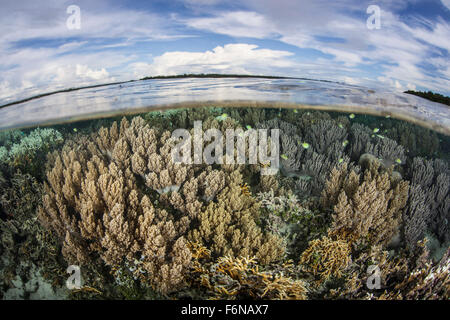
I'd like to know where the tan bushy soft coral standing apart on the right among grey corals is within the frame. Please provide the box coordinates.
[321,163,409,245]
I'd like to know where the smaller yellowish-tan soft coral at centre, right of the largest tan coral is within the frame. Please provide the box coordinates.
[190,171,285,264]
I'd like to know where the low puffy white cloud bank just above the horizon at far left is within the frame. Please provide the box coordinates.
[0,48,135,101]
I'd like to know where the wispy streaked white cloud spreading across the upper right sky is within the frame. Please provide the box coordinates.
[184,0,450,92]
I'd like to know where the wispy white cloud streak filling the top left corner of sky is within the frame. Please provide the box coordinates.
[0,1,186,44]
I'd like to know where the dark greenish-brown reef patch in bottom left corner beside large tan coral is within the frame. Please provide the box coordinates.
[0,172,68,299]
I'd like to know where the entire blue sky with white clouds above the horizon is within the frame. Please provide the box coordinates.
[0,0,450,104]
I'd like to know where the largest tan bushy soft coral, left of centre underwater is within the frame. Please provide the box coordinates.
[39,120,195,292]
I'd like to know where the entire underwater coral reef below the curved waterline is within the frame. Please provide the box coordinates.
[0,107,450,298]
